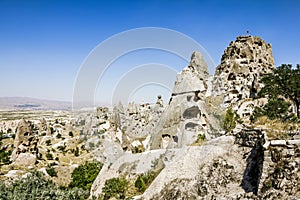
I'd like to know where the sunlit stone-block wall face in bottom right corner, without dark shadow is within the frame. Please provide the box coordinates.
[259,140,300,199]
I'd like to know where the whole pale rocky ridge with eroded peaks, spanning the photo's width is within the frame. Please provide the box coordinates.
[0,36,300,199]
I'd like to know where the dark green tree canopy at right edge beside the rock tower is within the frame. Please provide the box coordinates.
[259,64,300,118]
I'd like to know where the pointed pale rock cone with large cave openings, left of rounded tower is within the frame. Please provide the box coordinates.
[150,52,216,149]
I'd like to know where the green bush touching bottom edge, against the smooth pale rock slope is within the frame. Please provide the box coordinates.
[102,177,128,199]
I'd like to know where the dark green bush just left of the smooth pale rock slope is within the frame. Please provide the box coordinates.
[69,161,103,190]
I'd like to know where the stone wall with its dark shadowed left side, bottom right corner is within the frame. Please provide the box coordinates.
[235,129,300,199]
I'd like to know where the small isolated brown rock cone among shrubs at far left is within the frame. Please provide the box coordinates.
[11,120,38,166]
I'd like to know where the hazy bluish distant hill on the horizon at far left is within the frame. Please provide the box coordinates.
[0,97,72,110]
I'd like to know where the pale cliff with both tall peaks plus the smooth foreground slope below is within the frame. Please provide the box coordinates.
[91,36,299,199]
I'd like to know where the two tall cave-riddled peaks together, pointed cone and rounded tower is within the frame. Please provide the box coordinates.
[151,36,274,149]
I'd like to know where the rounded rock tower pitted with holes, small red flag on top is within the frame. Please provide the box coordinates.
[213,36,274,107]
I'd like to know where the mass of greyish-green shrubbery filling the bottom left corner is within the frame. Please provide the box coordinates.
[0,171,89,200]
